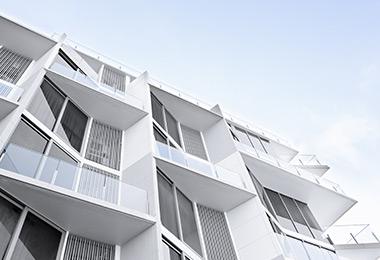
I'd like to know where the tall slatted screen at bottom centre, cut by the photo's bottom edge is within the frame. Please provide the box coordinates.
[198,205,237,260]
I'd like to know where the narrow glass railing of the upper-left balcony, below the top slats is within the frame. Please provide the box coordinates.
[50,62,144,110]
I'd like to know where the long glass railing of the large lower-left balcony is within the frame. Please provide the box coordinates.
[0,144,149,213]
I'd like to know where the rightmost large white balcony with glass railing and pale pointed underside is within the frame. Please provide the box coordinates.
[235,142,356,229]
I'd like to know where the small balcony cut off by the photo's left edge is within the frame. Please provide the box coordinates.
[0,79,24,120]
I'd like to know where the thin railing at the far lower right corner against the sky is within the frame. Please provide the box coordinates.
[328,224,380,245]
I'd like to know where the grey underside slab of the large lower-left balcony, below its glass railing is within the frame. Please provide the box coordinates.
[0,169,154,244]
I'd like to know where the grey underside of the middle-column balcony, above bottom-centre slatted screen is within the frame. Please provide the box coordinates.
[156,157,255,211]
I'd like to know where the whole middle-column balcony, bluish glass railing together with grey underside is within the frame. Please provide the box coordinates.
[155,142,255,211]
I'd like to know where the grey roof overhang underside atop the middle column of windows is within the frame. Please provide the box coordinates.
[151,87,222,131]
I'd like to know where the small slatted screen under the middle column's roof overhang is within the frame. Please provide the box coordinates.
[181,125,207,160]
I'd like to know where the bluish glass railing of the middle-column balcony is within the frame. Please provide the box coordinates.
[156,141,246,188]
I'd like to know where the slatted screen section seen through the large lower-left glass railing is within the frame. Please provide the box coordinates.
[78,165,119,203]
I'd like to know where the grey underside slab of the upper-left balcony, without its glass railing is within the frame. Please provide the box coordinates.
[46,70,148,130]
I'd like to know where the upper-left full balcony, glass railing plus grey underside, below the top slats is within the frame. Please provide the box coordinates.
[46,62,148,130]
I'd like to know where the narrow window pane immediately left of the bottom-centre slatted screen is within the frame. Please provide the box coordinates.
[177,189,202,255]
